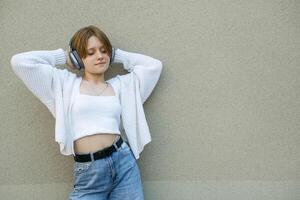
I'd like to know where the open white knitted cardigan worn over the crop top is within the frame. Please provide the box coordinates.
[10,49,163,159]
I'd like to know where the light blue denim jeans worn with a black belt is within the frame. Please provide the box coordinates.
[69,142,144,200]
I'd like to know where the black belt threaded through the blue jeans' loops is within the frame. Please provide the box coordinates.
[73,136,123,162]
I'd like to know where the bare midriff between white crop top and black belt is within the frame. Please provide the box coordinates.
[74,133,120,154]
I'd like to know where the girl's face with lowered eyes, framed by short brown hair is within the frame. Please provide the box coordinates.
[82,36,110,74]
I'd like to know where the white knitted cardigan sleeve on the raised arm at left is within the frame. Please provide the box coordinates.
[10,49,71,109]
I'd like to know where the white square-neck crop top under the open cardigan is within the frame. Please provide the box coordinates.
[71,82,121,141]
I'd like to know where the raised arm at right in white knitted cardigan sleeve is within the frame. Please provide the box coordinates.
[114,49,163,103]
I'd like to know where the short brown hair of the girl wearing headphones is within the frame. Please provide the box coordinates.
[70,25,112,58]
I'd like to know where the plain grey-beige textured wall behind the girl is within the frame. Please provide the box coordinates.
[0,0,300,200]
